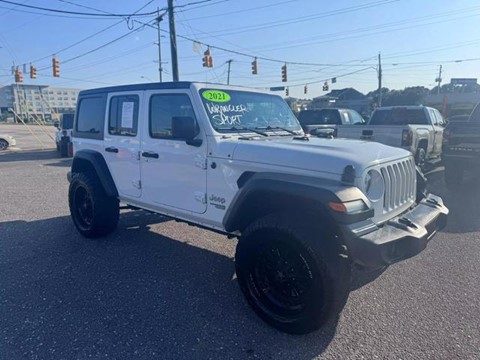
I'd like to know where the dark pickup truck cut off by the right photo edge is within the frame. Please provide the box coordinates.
[442,104,480,189]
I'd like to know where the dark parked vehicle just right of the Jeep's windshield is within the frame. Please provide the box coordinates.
[298,108,365,136]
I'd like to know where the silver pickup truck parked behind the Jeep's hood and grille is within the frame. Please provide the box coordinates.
[337,106,445,170]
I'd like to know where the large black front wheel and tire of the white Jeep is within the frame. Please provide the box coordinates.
[235,214,350,334]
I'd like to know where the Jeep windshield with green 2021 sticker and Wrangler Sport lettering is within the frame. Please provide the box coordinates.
[200,89,301,132]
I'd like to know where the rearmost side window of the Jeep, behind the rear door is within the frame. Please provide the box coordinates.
[75,96,106,139]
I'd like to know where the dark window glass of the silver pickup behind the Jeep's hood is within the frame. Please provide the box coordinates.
[369,108,428,125]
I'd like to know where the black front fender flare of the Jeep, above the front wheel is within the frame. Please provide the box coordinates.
[223,172,373,232]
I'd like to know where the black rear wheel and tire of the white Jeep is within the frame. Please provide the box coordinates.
[68,173,120,238]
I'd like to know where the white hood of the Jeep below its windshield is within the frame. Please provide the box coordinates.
[232,137,411,175]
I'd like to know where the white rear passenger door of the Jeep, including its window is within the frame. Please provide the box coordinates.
[103,91,143,198]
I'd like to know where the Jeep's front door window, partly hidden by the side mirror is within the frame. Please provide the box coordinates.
[149,94,196,139]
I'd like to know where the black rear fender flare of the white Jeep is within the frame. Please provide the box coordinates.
[72,149,118,197]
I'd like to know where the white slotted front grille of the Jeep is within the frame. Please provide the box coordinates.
[380,158,416,213]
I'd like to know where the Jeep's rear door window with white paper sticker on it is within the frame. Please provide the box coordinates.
[108,95,139,136]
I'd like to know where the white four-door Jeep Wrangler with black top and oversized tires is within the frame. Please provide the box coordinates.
[69,82,448,334]
